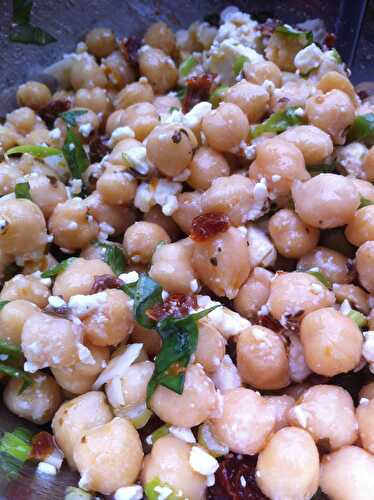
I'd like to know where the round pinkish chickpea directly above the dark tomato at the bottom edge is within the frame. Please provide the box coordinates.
[210,388,275,455]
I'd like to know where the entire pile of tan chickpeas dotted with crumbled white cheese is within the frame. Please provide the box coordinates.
[0,7,374,500]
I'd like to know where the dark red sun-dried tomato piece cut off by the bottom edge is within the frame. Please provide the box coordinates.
[206,453,268,500]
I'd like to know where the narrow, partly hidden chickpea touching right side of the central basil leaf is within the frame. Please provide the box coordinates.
[195,321,226,373]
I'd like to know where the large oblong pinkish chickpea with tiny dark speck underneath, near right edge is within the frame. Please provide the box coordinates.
[292,174,360,229]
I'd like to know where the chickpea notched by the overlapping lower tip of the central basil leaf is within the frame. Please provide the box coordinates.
[150,365,217,427]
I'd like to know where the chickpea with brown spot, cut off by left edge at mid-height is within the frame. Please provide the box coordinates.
[0,198,47,256]
